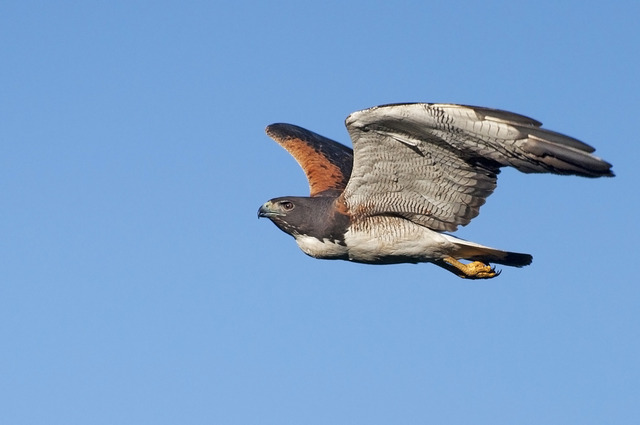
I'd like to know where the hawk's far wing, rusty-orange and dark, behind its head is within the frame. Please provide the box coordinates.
[266,124,353,196]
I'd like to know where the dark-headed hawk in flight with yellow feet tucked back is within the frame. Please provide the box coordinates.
[258,103,614,279]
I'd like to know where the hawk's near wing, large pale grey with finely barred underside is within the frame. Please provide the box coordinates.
[344,103,613,231]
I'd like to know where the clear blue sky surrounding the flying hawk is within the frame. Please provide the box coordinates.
[0,0,640,425]
